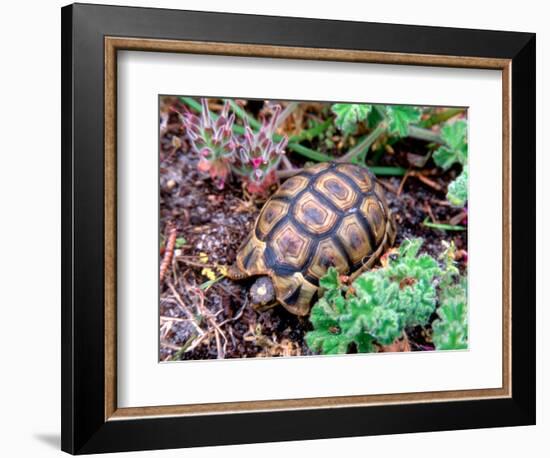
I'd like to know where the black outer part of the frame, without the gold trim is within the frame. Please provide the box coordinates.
[61,4,536,454]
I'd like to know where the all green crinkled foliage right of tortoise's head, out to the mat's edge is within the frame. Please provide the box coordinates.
[305,239,468,354]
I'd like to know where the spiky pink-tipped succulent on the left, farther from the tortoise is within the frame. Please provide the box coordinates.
[183,98,237,189]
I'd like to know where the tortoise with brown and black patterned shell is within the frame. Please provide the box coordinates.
[228,163,396,316]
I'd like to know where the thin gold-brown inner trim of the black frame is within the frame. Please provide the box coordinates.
[104,37,512,421]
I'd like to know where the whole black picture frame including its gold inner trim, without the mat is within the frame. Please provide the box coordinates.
[61,4,536,454]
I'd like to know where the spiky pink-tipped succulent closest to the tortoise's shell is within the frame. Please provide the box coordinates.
[231,106,288,194]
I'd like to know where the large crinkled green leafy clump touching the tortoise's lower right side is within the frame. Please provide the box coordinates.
[305,239,442,354]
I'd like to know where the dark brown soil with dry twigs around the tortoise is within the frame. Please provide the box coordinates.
[160,99,467,361]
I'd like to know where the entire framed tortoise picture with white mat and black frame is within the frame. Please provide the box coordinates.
[62,4,536,454]
